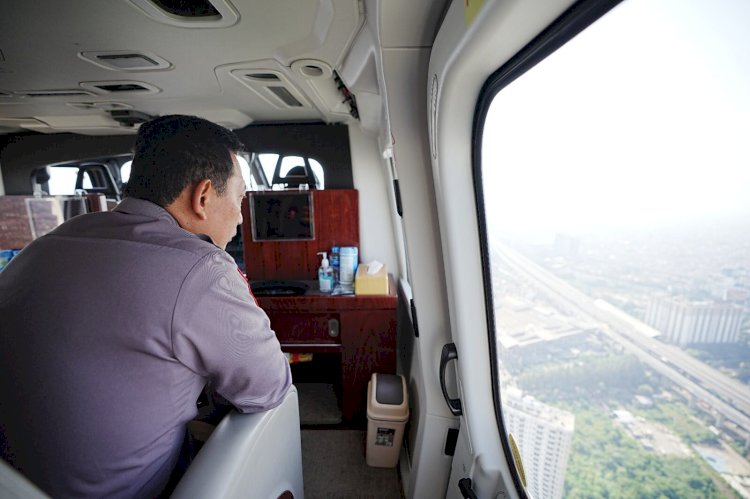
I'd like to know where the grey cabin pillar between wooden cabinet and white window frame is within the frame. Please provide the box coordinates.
[382,42,458,497]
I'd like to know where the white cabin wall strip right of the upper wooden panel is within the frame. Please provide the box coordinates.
[349,126,401,279]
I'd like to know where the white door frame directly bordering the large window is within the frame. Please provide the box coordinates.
[429,0,571,497]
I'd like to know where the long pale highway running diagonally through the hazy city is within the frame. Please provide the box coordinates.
[492,241,750,433]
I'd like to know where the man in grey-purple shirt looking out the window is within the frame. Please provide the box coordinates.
[0,116,291,497]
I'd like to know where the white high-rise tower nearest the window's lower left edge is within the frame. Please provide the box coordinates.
[503,388,575,499]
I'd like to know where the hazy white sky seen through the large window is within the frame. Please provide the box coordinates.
[483,0,750,236]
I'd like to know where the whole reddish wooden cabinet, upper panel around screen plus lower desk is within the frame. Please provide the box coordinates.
[242,189,397,421]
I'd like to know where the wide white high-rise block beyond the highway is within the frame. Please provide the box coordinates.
[645,298,744,346]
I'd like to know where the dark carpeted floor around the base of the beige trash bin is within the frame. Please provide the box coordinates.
[302,429,403,499]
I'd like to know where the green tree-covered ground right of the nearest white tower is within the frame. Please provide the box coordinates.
[564,404,727,499]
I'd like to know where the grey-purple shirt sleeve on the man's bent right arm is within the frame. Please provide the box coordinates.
[172,251,292,413]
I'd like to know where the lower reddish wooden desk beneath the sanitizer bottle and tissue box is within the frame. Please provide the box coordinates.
[258,286,397,421]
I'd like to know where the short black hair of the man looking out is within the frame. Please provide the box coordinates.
[124,114,244,207]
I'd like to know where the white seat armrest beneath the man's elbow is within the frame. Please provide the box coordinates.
[172,386,304,499]
